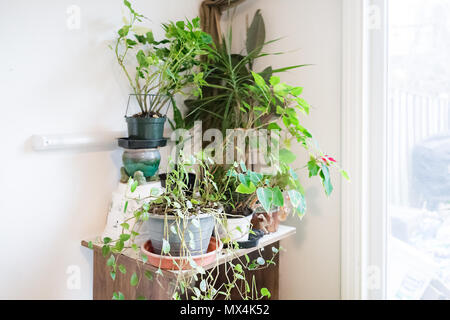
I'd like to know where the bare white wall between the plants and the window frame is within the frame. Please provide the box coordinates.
[224,0,342,299]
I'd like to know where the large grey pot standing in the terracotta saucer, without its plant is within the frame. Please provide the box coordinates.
[145,214,215,256]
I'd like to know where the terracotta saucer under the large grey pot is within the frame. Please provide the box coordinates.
[141,237,223,270]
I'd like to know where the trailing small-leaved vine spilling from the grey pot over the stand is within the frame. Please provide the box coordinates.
[89,153,279,300]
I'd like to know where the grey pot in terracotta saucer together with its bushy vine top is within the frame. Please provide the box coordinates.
[142,153,223,256]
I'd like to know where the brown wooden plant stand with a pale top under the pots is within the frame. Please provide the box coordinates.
[81,225,296,300]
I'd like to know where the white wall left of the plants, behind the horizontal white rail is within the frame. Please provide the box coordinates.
[0,0,200,299]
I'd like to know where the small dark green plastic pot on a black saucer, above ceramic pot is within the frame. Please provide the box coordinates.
[125,116,166,140]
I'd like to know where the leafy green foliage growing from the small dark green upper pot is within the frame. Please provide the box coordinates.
[114,0,212,117]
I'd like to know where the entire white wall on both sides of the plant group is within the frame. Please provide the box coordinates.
[0,0,341,299]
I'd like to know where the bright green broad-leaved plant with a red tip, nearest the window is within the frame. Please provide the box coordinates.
[229,72,348,216]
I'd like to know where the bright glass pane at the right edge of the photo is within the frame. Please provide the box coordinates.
[387,0,450,299]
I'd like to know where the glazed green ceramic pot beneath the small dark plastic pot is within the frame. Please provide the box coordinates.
[122,149,161,178]
